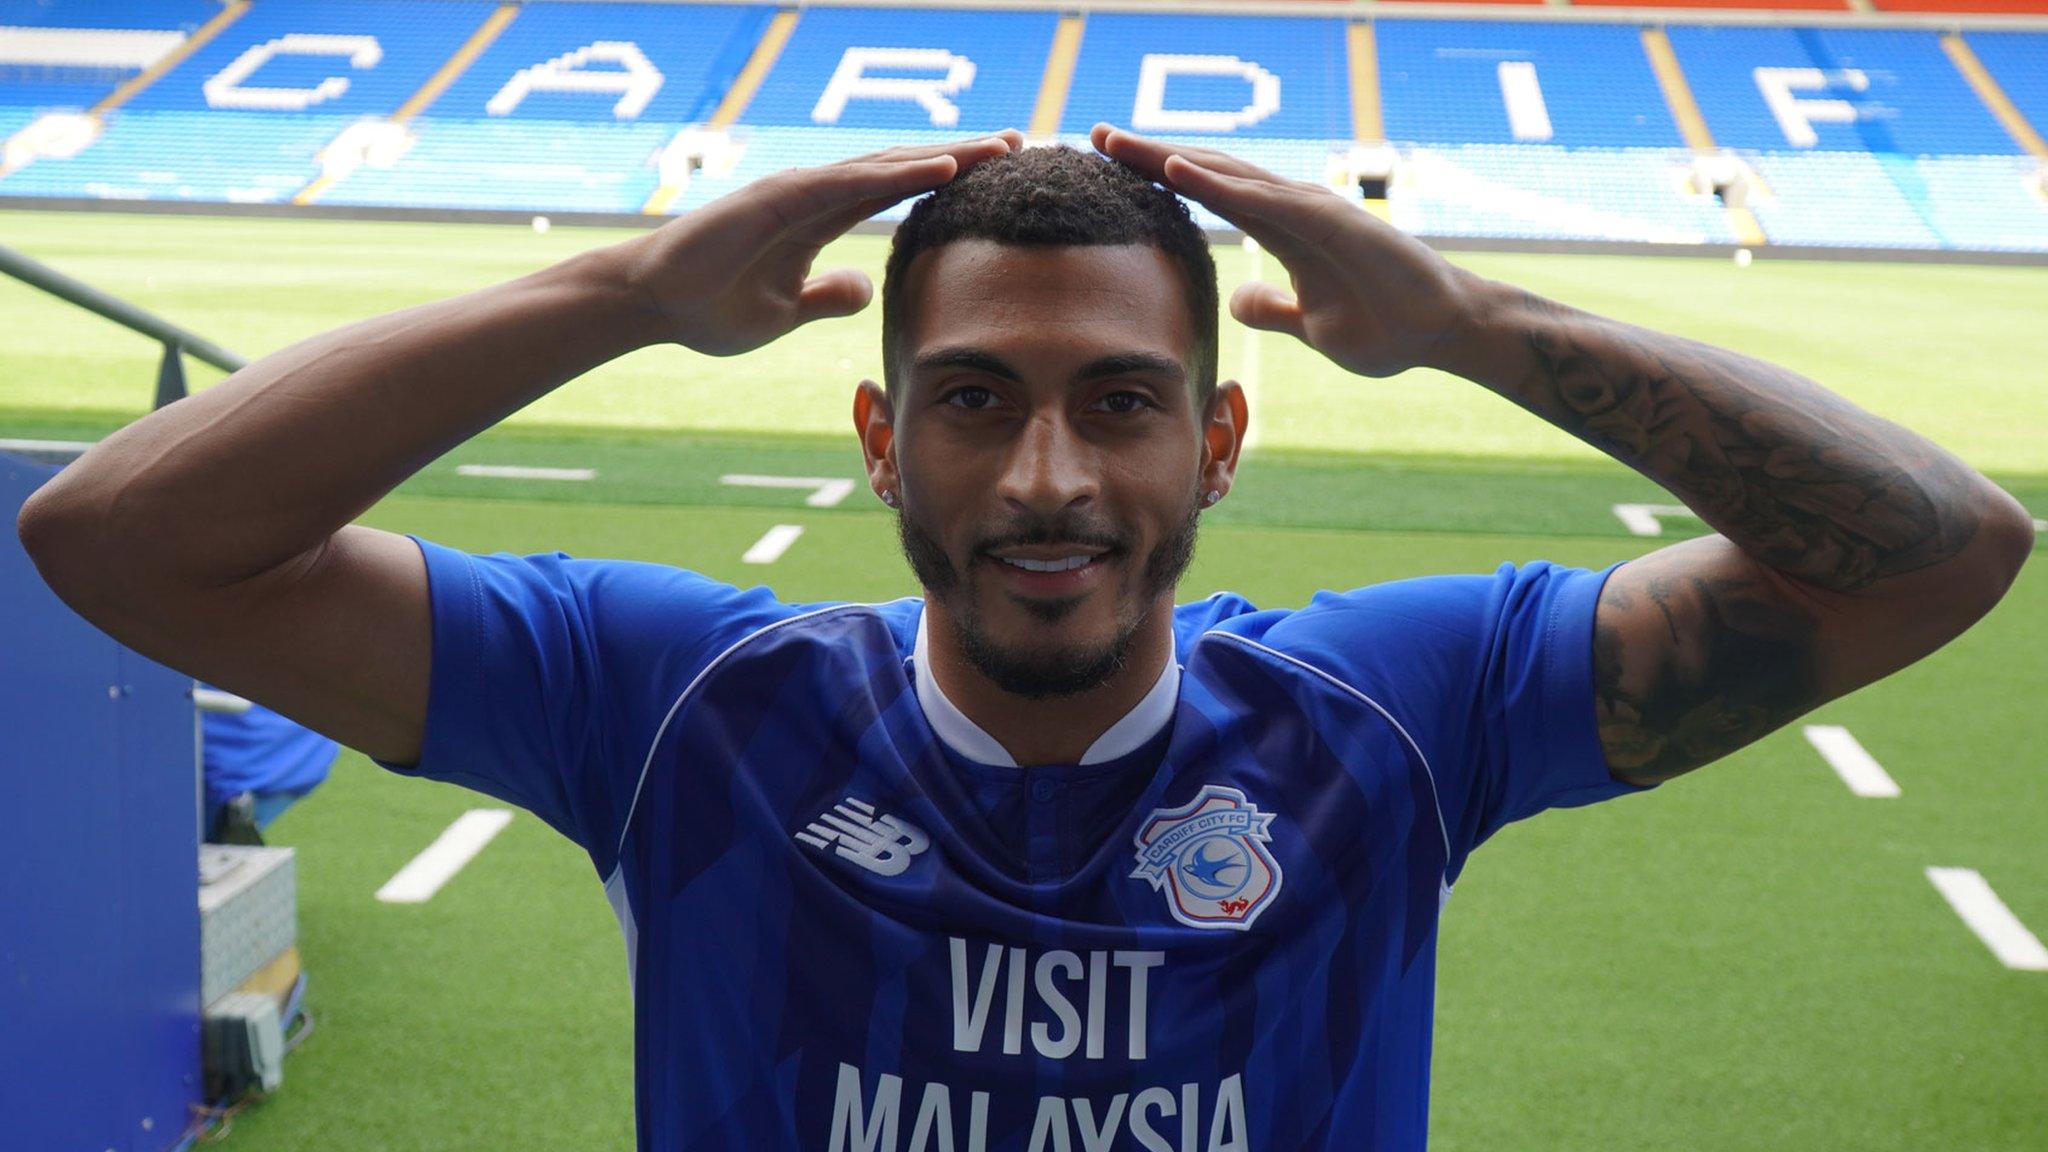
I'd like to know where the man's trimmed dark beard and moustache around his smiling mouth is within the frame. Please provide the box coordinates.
[897,479,1200,699]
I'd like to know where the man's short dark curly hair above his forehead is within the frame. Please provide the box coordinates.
[883,146,1217,408]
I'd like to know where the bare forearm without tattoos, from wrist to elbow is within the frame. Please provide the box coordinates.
[23,242,649,582]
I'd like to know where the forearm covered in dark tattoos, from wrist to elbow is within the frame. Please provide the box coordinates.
[1446,272,2017,592]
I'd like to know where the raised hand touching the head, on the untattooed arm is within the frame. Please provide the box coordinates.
[625,131,1024,357]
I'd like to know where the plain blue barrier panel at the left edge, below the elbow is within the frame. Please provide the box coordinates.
[0,453,203,1152]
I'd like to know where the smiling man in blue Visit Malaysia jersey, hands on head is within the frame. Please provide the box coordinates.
[20,127,2032,1152]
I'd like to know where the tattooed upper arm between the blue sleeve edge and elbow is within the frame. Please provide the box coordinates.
[1593,560,1823,783]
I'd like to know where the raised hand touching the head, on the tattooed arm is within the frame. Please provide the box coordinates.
[1094,125,1479,375]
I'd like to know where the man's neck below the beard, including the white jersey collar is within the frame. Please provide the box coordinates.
[924,599,1174,767]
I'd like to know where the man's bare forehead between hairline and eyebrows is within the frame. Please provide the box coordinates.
[903,240,1194,363]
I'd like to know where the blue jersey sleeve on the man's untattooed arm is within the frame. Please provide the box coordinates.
[377,537,799,875]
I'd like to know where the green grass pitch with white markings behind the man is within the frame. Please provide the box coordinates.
[0,213,2048,1152]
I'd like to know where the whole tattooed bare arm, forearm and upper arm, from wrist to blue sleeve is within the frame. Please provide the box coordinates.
[1501,295,1982,783]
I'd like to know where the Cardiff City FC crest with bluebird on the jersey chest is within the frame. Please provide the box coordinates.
[1130,783,1280,931]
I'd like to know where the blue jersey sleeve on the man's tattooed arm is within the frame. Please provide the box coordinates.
[1266,562,1645,861]
